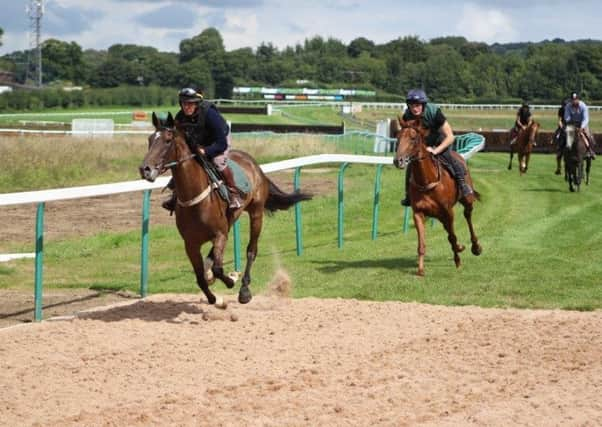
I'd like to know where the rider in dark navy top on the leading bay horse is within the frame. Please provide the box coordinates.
[163,88,241,211]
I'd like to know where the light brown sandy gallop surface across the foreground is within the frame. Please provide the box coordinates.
[0,292,602,426]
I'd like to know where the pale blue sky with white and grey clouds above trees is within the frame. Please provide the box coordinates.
[0,0,602,55]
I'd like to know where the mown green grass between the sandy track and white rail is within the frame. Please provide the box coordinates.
[0,153,602,310]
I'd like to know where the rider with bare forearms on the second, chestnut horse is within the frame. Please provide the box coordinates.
[401,89,474,206]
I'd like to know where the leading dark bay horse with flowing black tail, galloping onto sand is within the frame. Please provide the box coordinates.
[140,113,311,304]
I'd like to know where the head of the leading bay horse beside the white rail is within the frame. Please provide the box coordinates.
[140,112,177,182]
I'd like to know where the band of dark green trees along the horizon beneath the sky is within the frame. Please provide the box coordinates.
[0,28,602,107]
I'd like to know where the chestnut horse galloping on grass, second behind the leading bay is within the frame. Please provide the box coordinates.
[393,118,482,276]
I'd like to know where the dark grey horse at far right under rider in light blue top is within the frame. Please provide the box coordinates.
[564,125,592,192]
